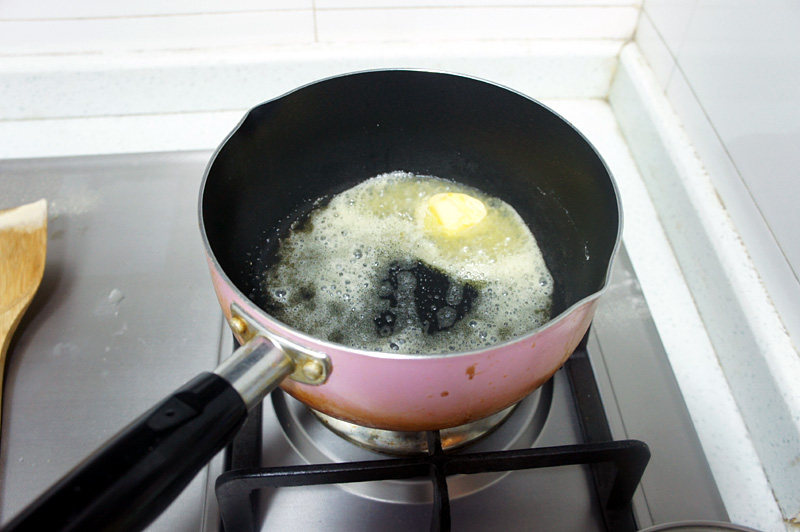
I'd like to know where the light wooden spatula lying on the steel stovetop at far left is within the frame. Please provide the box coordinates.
[0,199,47,428]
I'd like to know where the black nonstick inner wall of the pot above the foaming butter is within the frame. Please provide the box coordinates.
[201,70,620,324]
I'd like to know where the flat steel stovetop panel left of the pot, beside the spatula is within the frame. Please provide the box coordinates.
[0,152,222,530]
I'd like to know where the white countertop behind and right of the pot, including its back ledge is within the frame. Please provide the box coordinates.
[0,40,791,531]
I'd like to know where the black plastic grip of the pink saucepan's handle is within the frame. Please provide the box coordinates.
[4,373,247,532]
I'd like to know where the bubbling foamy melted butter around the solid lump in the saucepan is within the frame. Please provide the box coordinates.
[263,171,553,354]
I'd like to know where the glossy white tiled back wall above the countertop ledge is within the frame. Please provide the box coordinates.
[0,0,641,57]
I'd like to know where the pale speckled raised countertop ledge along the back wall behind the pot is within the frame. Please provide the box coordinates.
[0,41,621,125]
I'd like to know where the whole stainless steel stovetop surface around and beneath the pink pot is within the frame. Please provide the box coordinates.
[0,152,727,531]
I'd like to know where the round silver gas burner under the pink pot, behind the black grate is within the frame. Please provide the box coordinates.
[272,381,553,503]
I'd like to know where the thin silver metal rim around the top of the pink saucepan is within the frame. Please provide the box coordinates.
[197,68,623,360]
